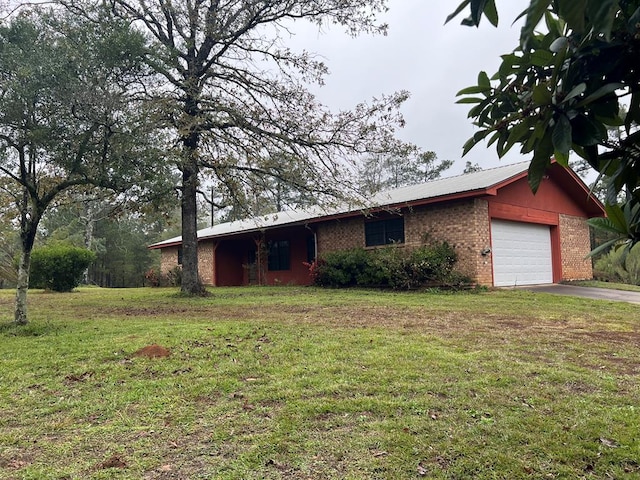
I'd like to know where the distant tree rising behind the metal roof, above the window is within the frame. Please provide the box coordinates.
[358,147,453,195]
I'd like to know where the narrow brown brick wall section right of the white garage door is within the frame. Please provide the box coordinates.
[558,215,593,280]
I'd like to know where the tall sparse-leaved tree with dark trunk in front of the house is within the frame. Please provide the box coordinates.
[91,0,407,294]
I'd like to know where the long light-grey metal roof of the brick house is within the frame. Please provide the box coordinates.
[150,161,529,248]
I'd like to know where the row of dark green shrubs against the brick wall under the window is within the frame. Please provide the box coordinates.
[309,242,470,290]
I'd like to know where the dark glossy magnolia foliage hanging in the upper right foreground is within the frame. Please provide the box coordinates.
[447,0,640,253]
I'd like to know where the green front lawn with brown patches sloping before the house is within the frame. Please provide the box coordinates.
[0,287,640,479]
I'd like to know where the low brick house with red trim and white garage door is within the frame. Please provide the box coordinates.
[149,162,604,286]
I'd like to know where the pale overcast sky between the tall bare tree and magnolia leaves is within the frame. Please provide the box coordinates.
[292,0,528,176]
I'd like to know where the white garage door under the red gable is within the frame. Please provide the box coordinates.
[491,220,553,287]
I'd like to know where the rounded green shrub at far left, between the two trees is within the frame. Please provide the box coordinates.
[29,245,96,292]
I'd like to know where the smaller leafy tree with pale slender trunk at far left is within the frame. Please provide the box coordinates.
[0,9,170,324]
